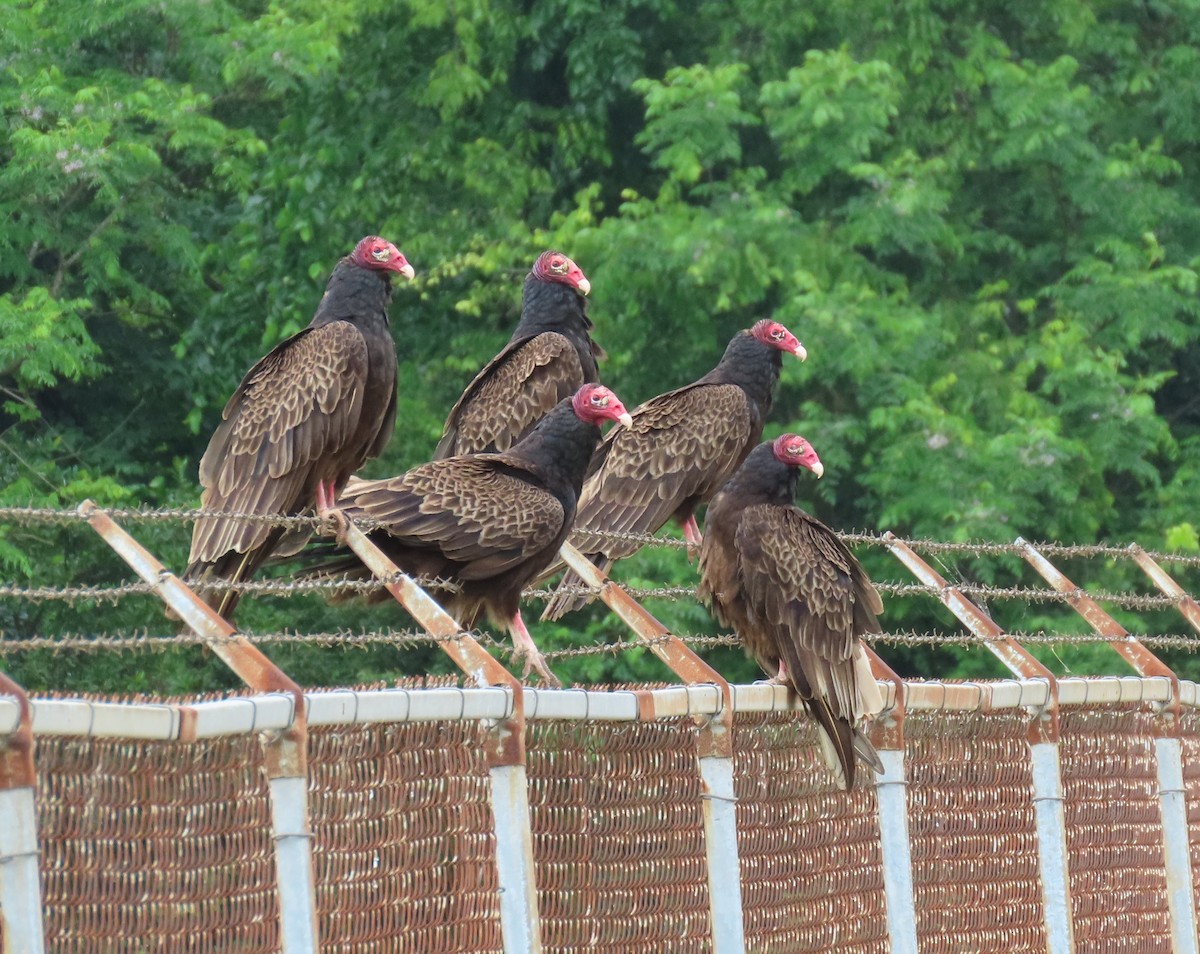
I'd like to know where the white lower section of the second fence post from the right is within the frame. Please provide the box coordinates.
[1030,742,1075,954]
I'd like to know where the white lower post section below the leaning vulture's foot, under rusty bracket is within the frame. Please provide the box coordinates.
[491,766,541,954]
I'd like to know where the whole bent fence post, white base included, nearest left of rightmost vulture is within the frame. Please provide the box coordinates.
[560,544,745,954]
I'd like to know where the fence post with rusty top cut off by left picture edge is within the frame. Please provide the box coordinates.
[0,672,46,954]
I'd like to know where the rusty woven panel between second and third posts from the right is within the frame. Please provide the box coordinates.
[905,713,1046,954]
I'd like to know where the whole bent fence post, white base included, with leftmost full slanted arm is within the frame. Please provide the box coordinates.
[78,500,320,954]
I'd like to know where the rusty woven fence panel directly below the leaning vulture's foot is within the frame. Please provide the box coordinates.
[308,721,503,954]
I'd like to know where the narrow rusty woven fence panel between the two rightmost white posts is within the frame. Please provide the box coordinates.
[1060,709,1171,954]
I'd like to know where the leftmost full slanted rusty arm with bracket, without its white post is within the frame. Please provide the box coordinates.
[78,500,308,779]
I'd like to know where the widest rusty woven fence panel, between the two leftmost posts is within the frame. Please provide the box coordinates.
[37,737,280,954]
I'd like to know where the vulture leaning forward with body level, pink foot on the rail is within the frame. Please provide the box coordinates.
[310,384,629,685]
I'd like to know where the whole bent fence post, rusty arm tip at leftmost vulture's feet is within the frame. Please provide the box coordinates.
[338,520,542,954]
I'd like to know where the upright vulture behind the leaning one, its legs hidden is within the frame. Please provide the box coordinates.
[433,252,604,460]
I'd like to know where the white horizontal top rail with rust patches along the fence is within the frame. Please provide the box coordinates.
[0,676,1185,742]
